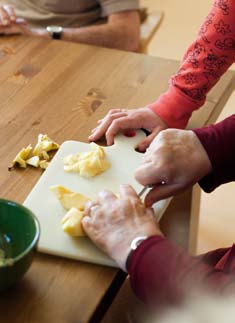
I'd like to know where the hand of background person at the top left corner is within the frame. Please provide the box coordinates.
[0,4,27,35]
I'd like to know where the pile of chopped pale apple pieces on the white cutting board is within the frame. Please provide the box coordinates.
[64,143,110,177]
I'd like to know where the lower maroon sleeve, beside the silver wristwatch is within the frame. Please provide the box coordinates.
[128,236,235,306]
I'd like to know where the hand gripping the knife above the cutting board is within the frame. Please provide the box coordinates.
[135,129,212,207]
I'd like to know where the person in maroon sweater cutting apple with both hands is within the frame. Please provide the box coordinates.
[82,115,235,306]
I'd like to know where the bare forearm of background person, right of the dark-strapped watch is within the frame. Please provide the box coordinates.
[62,19,139,51]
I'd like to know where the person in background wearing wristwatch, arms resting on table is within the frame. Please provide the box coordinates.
[0,0,140,51]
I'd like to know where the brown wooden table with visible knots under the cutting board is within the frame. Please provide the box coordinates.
[0,36,233,323]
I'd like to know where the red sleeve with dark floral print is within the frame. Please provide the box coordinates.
[149,0,235,129]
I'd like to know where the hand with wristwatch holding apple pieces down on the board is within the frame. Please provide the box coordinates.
[82,185,162,270]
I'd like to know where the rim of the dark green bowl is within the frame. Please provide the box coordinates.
[0,198,41,268]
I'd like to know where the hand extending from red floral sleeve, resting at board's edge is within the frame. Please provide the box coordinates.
[88,107,167,151]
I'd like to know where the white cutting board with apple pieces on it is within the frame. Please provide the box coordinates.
[24,130,170,267]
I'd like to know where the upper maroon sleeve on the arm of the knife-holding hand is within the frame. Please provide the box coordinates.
[193,115,235,193]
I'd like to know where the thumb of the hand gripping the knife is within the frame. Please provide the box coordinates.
[144,184,180,207]
